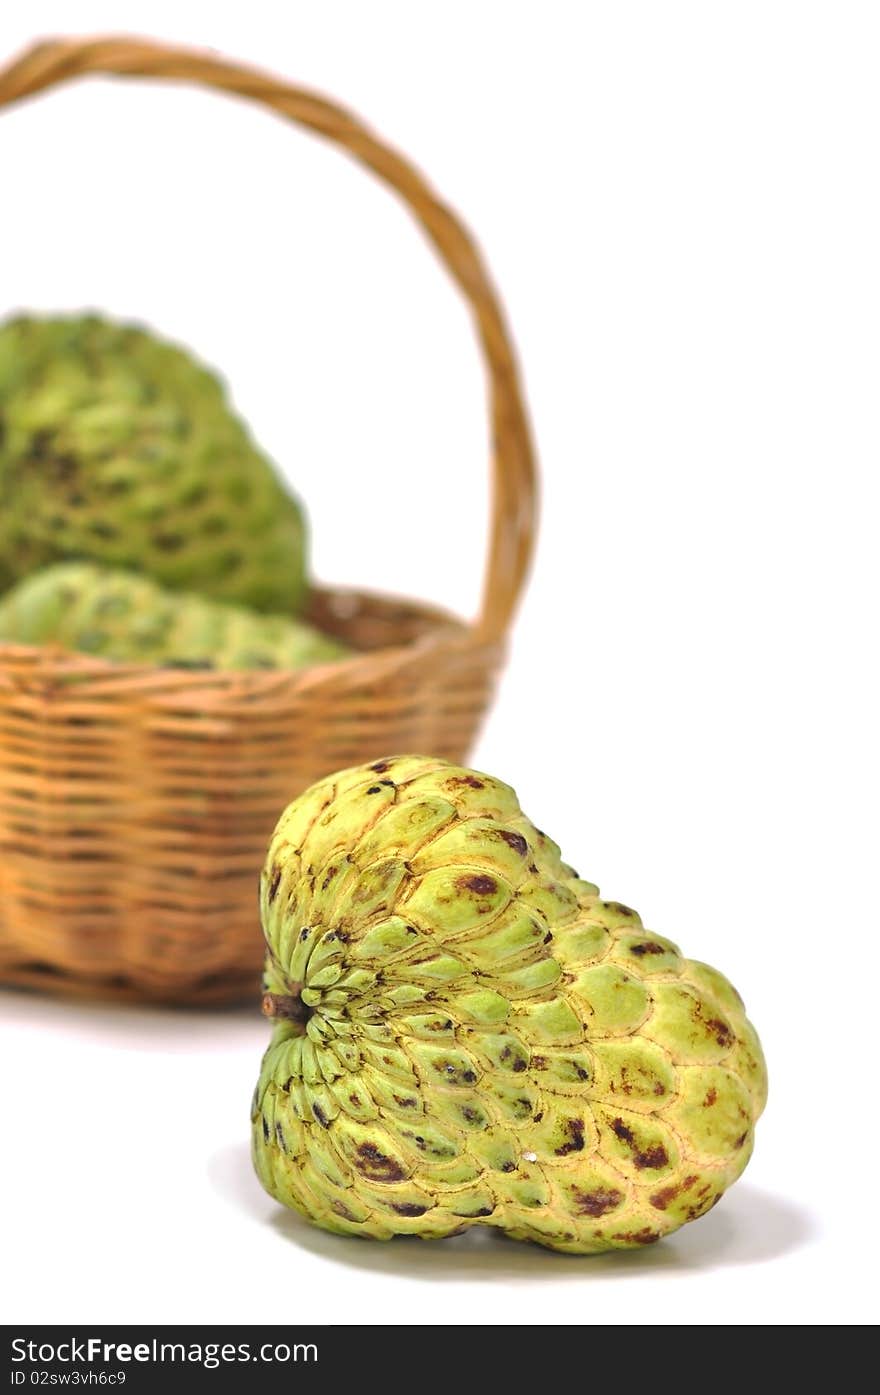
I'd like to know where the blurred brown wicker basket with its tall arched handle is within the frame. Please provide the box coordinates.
[0,39,534,1003]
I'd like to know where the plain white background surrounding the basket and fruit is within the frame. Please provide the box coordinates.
[0,0,880,1324]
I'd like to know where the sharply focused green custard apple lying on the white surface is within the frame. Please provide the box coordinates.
[252,756,766,1253]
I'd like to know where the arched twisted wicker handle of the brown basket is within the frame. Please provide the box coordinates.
[0,38,537,640]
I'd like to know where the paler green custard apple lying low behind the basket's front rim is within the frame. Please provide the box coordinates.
[0,562,349,668]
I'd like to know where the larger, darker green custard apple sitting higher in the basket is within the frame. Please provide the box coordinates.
[0,317,305,612]
